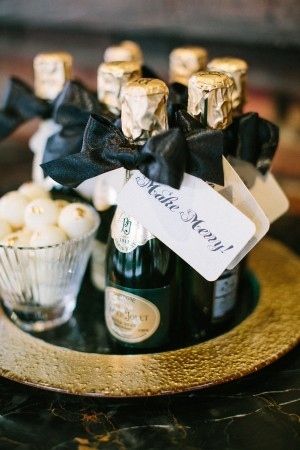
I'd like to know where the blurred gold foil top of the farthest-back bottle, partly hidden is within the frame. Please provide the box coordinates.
[103,41,144,65]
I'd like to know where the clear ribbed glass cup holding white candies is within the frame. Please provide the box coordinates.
[0,213,99,331]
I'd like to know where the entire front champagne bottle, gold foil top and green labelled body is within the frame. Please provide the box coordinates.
[105,78,178,352]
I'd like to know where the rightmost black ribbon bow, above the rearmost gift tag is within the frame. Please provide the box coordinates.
[224,112,279,175]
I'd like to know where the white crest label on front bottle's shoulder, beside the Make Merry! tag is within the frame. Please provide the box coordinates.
[111,208,154,253]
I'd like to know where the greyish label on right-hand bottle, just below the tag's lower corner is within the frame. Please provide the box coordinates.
[212,269,238,320]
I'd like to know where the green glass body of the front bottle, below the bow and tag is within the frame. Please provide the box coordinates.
[105,209,178,352]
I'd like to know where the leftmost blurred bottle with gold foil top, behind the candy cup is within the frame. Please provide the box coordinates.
[29,52,73,190]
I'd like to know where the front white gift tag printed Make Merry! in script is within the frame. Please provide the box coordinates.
[118,171,255,281]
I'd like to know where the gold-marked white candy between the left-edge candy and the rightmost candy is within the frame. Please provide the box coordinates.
[24,198,59,231]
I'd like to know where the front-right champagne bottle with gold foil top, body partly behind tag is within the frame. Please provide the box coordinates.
[184,72,239,342]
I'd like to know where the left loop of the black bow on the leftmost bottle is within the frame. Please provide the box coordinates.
[0,77,51,139]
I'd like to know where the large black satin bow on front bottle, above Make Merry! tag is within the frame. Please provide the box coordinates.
[42,114,223,189]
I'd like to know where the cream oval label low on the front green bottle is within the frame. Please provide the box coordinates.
[105,287,160,343]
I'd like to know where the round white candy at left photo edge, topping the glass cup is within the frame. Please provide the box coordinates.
[0,191,29,229]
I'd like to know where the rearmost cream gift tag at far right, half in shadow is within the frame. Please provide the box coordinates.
[230,158,289,223]
